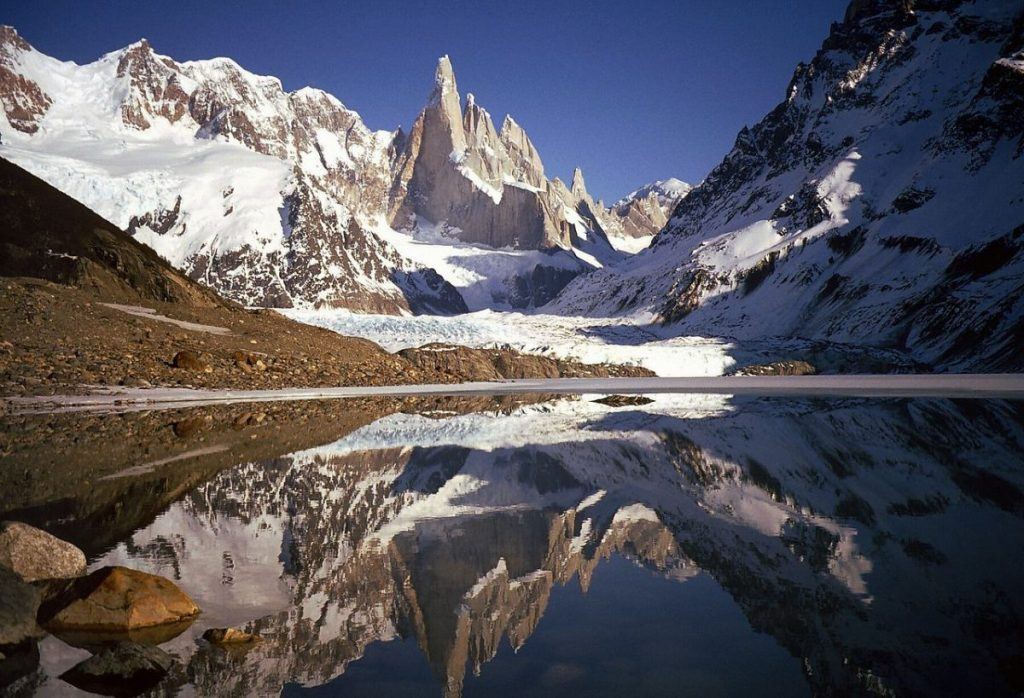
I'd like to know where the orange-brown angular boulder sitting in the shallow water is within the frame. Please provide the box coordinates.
[38,567,199,632]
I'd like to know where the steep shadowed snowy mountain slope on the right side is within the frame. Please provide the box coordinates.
[549,0,1024,370]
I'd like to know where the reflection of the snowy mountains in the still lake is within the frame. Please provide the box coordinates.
[4,397,1024,696]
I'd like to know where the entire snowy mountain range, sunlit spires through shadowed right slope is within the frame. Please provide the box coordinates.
[0,0,1024,370]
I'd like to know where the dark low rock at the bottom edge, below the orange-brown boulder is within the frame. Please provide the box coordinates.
[60,643,174,696]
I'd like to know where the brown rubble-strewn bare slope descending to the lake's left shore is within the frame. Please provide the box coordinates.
[0,159,649,395]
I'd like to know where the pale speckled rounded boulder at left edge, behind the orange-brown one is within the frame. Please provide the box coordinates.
[0,521,86,581]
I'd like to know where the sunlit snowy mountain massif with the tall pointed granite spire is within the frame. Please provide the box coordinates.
[0,27,667,313]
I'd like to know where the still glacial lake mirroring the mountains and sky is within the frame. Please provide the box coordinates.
[0,394,1024,698]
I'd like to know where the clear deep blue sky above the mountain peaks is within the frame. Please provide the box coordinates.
[0,0,848,200]
